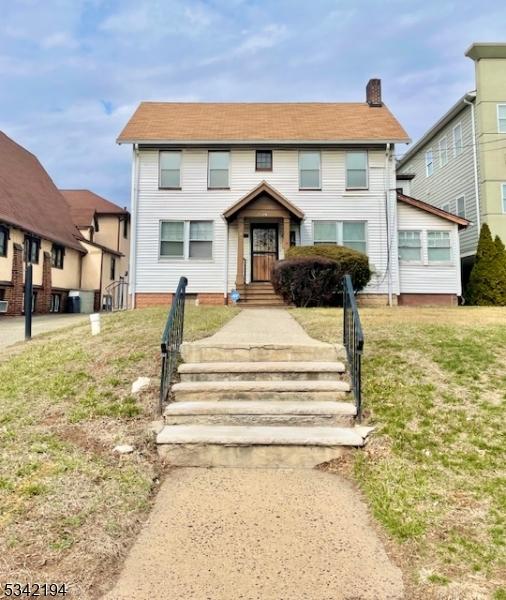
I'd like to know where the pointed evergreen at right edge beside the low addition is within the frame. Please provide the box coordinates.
[466,223,506,306]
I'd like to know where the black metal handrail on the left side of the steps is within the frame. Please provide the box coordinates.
[160,277,188,411]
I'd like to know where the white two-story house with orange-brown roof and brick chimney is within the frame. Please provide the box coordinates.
[118,79,468,307]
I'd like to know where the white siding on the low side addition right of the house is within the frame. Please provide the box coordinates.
[397,202,462,296]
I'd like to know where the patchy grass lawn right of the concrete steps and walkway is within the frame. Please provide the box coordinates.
[292,307,506,600]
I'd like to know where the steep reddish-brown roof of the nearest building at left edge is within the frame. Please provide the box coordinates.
[0,131,84,252]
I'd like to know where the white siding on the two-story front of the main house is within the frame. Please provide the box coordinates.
[135,148,398,294]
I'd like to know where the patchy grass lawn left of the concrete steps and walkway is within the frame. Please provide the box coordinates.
[0,306,237,600]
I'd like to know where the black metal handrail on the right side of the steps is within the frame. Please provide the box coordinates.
[343,275,364,421]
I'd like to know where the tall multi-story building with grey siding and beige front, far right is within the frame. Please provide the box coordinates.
[397,44,506,283]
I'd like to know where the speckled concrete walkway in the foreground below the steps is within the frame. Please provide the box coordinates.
[105,468,403,600]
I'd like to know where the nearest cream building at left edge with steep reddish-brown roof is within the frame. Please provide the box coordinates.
[0,132,86,316]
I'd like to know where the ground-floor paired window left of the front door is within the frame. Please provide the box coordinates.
[160,221,214,260]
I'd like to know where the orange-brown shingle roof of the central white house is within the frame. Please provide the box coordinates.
[118,102,409,143]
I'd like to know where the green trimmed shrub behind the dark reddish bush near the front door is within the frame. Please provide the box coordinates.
[286,244,371,291]
